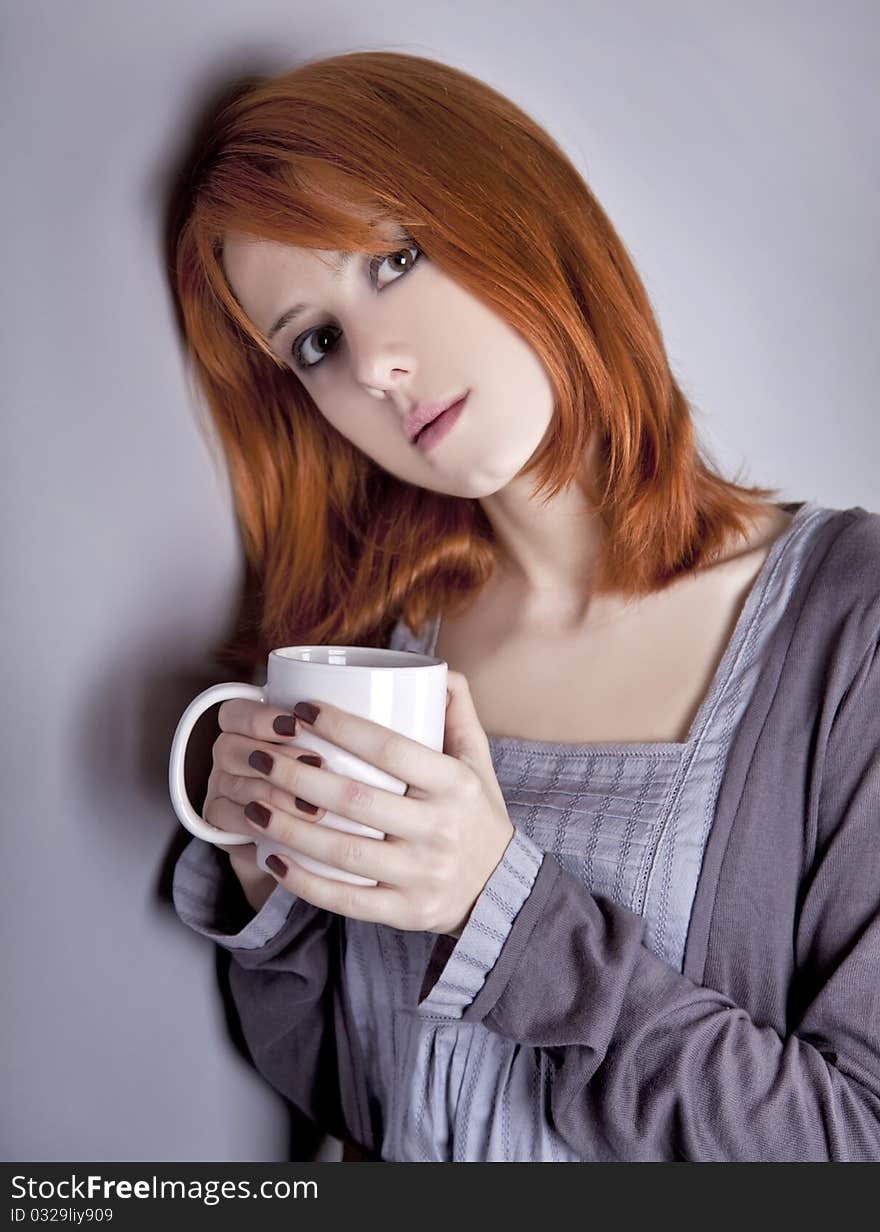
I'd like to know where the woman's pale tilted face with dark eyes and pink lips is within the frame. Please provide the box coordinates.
[223,235,553,498]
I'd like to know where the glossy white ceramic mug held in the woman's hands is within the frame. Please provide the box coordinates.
[168,646,446,886]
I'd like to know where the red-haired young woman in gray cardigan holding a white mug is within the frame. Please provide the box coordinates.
[174,52,880,1161]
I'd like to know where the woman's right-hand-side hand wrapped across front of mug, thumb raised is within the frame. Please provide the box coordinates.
[234,671,514,938]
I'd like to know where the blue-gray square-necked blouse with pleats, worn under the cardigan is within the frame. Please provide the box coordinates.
[344,504,833,1162]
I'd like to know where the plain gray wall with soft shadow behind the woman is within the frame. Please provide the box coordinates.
[0,0,880,1162]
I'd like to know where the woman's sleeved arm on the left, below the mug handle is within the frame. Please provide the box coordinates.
[173,838,370,1146]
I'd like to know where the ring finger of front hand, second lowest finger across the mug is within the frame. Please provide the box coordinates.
[241,808,413,886]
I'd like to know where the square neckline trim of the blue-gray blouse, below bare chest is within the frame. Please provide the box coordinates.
[425,500,821,759]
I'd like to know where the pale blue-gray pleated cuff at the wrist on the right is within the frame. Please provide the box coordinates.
[418,830,544,1019]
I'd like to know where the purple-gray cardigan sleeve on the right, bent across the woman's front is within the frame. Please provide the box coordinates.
[423,643,880,1161]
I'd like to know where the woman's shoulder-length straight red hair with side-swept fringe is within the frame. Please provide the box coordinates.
[174,52,778,667]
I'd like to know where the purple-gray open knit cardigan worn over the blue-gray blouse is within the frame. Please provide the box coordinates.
[175,508,880,1161]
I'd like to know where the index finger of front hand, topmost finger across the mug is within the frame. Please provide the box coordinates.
[293,701,455,792]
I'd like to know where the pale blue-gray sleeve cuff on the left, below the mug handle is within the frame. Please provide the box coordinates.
[171,838,298,950]
